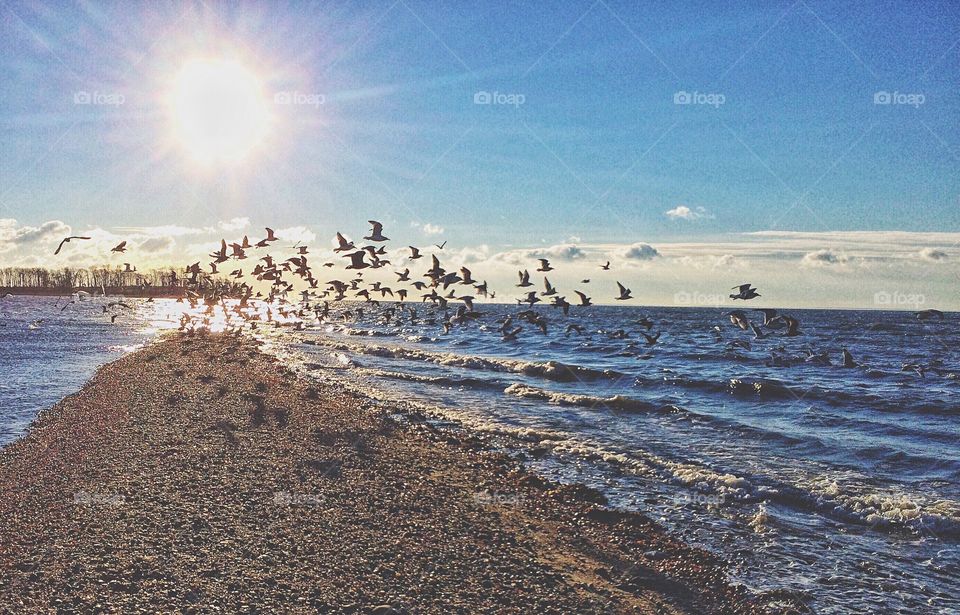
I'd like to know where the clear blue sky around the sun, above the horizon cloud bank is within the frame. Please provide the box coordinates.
[0,0,960,308]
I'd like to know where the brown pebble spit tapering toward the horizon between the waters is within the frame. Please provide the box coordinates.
[0,333,802,613]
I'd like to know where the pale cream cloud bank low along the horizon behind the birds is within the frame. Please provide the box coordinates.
[0,217,960,310]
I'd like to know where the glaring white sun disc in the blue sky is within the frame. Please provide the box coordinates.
[169,60,270,164]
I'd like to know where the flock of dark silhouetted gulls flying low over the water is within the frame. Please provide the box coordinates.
[28,220,943,369]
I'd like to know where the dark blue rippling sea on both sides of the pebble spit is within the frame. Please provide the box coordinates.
[0,296,960,613]
